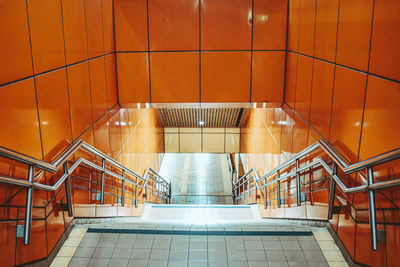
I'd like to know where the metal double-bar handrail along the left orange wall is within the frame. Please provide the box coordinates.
[0,140,171,245]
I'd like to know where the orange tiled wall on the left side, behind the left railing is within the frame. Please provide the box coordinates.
[0,0,117,266]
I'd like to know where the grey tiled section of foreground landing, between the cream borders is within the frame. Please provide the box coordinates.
[69,233,329,267]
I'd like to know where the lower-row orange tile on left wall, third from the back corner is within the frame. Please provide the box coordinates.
[67,62,92,139]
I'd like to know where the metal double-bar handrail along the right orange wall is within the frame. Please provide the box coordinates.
[232,140,400,250]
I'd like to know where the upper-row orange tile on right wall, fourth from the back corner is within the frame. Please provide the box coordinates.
[336,0,373,71]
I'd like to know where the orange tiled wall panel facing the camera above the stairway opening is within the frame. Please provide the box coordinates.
[115,0,287,104]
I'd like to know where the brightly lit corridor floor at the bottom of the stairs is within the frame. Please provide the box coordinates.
[160,153,233,204]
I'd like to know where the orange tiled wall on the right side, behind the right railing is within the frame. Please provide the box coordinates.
[241,0,400,266]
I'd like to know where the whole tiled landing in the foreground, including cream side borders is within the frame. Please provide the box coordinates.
[52,223,347,267]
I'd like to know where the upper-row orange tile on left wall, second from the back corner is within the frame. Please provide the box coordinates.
[85,0,104,58]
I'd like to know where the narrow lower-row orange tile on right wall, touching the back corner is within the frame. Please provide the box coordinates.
[285,52,298,108]
